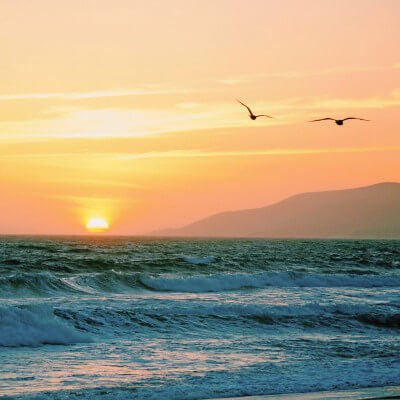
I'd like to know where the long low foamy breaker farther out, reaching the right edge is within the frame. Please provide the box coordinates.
[140,272,400,293]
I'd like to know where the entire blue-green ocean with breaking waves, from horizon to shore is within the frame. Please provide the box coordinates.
[0,236,400,400]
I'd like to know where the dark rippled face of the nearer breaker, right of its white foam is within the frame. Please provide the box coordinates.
[48,299,400,336]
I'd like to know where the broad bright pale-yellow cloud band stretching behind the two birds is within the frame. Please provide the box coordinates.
[0,89,400,143]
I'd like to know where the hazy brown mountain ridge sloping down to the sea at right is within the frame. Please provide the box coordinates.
[152,182,400,239]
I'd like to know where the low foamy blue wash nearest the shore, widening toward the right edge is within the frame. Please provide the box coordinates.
[13,359,400,400]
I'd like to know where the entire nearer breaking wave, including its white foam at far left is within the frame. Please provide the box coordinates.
[0,299,400,347]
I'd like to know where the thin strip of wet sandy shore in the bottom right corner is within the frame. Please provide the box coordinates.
[203,386,400,400]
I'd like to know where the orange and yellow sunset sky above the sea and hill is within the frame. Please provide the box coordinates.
[0,0,400,235]
